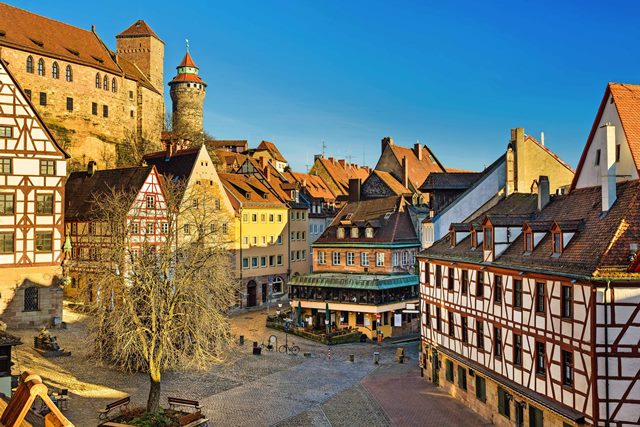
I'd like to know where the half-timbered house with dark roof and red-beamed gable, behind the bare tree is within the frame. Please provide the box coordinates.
[65,162,165,301]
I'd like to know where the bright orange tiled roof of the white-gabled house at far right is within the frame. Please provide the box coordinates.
[571,83,640,190]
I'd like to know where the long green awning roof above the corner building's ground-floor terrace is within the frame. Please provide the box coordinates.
[288,273,418,290]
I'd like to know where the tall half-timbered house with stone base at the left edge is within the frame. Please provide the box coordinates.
[0,60,68,326]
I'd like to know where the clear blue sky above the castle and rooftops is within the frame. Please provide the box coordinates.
[12,0,640,171]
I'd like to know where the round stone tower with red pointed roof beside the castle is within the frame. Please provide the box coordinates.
[169,50,207,141]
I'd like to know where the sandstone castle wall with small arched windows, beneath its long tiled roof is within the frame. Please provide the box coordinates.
[0,47,164,169]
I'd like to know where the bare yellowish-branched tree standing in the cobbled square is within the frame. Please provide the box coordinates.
[85,179,233,412]
